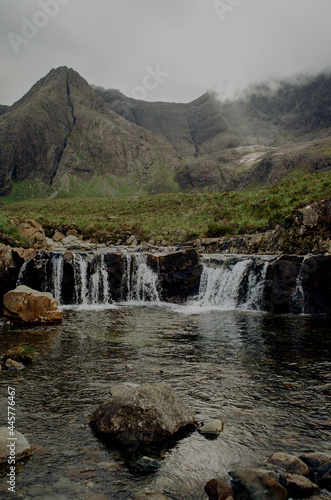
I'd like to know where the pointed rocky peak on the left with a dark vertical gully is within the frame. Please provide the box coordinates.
[0,68,179,195]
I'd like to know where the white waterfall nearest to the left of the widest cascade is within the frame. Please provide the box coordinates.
[123,253,160,302]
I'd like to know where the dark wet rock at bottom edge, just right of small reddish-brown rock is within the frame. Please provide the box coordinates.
[229,470,287,500]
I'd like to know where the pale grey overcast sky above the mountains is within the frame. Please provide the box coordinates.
[0,0,331,104]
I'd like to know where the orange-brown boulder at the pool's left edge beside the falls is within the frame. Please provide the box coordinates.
[3,285,63,323]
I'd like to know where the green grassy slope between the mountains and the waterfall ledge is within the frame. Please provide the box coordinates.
[0,172,331,242]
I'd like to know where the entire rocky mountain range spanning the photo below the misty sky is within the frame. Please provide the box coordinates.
[0,67,331,198]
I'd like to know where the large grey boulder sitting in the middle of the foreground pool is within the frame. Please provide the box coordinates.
[90,383,197,445]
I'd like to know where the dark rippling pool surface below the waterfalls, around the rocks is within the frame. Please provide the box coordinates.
[0,305,331,500]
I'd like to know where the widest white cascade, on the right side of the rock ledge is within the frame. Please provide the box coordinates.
[191,257,267,310]
